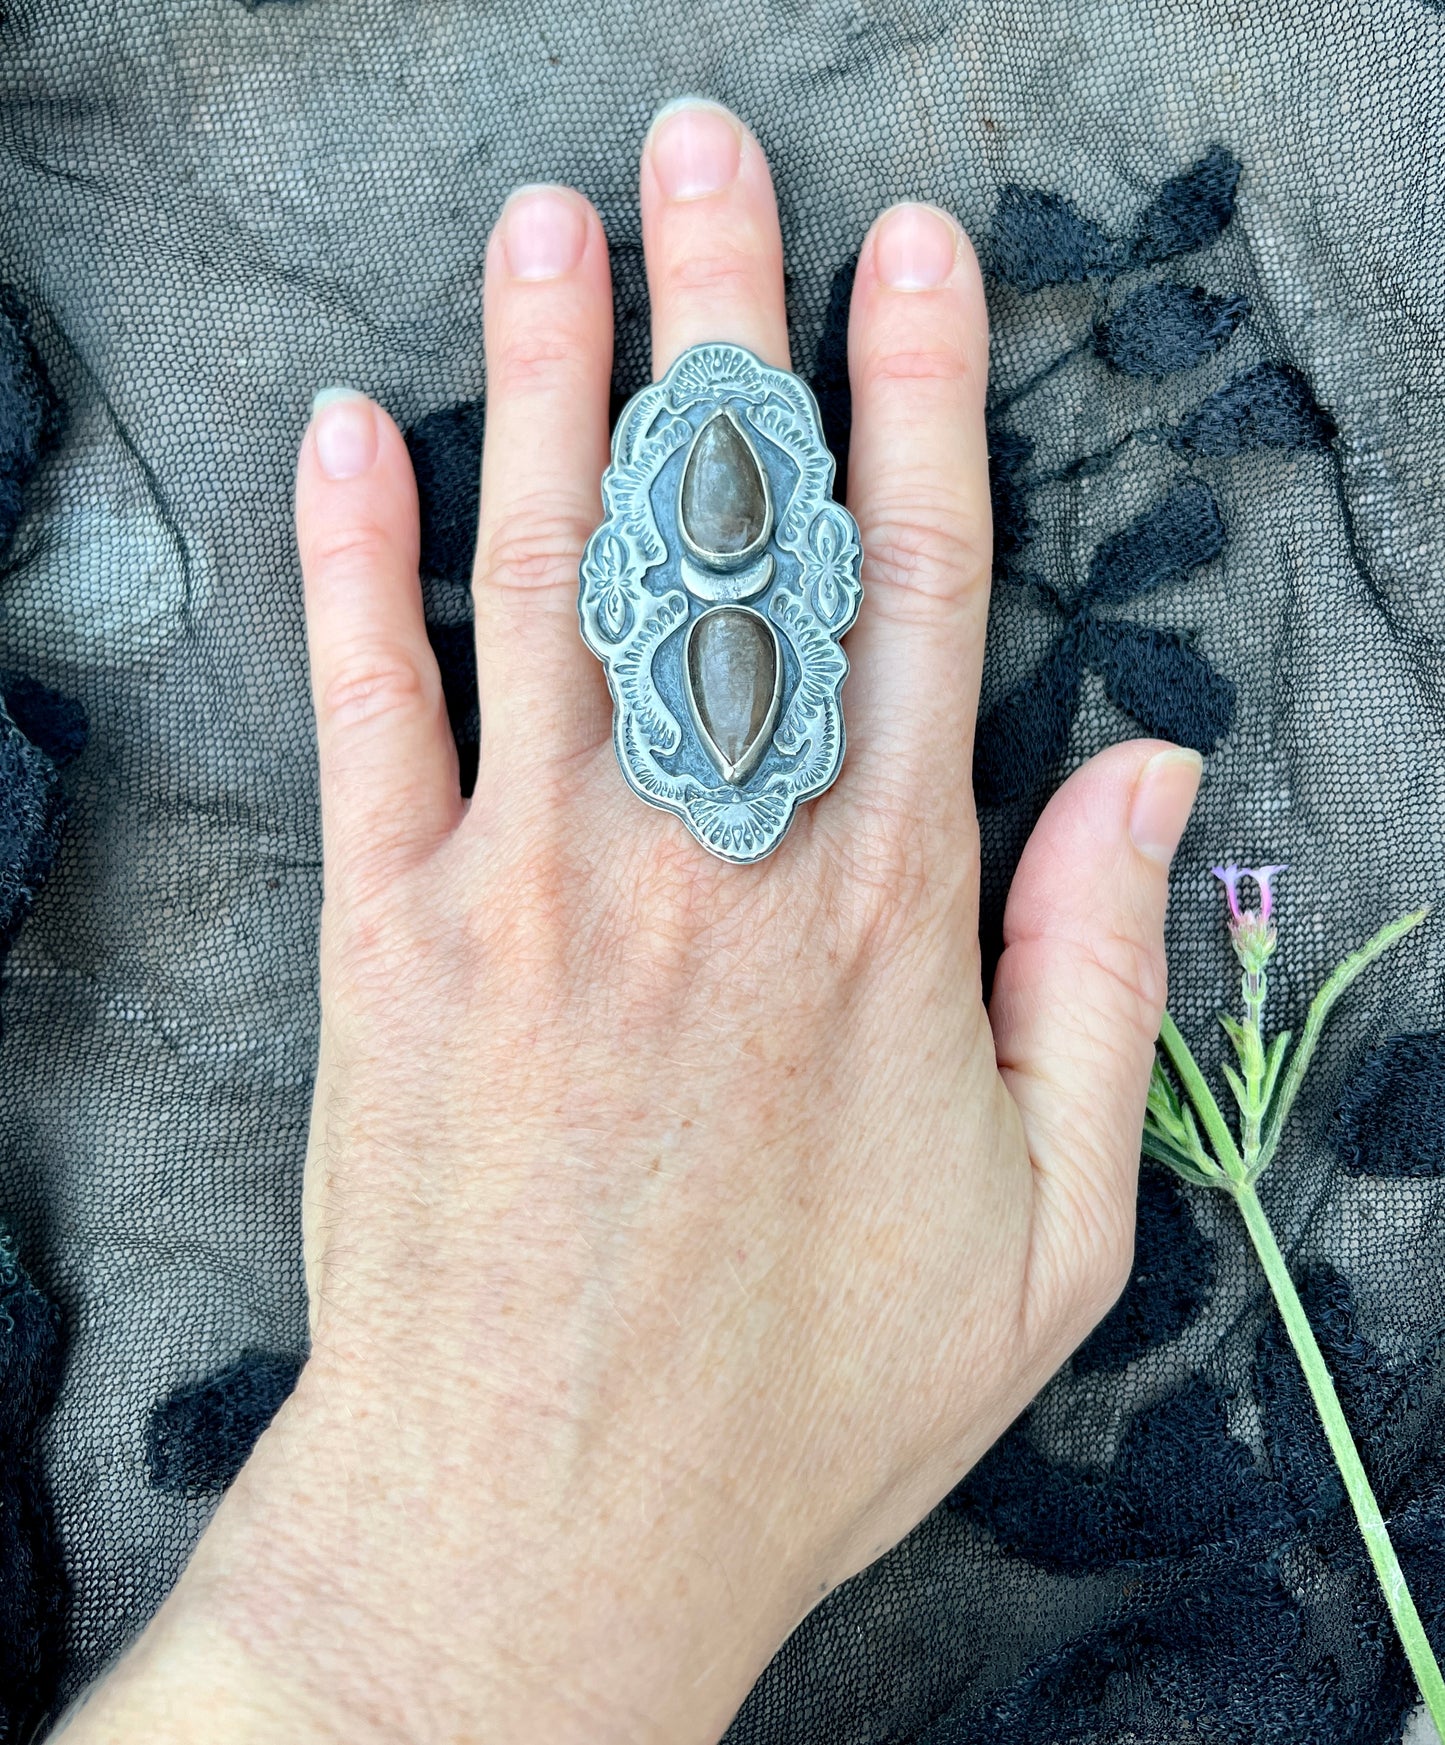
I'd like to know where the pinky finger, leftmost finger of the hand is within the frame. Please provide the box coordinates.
[297,389,464,888]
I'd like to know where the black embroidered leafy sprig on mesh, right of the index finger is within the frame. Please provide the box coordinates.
[974,147,1335,804]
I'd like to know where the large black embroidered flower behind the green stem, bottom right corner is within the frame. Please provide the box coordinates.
[949,1267,1445,1745]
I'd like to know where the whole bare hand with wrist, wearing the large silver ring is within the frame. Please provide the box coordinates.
[65,106,1199,1745]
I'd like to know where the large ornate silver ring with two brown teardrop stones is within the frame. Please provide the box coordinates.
[578,342,862,862]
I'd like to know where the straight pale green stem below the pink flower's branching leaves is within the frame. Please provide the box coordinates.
[1229,1172,1445,1740]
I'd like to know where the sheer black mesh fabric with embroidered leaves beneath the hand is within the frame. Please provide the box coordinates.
[0,0,1445,1745]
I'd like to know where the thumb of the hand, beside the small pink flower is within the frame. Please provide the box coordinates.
[990,740,1202,1349]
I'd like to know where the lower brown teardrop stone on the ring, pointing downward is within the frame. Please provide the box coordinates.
[688,606,780,785]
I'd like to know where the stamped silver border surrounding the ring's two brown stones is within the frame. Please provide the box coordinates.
[578,342,862,864]
